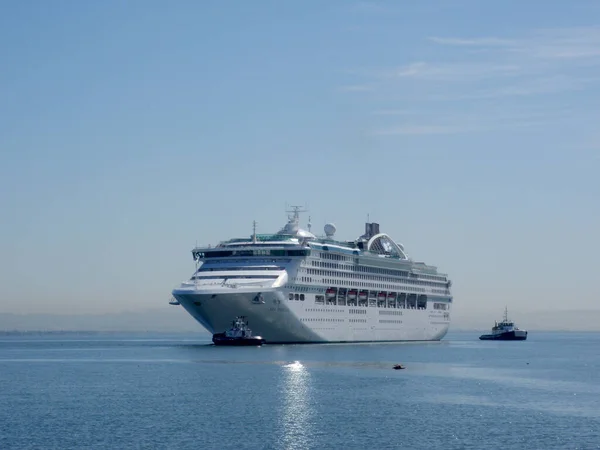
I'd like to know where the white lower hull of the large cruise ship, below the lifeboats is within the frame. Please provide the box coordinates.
[173,284,450,344]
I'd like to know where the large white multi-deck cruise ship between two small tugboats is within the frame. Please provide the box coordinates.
[170,207,452,344]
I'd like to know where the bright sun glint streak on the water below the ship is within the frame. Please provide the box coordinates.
[280,361,313,448]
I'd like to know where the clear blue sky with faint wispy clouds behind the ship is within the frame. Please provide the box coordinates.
[0,0,600,324]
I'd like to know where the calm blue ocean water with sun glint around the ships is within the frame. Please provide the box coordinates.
[0,332,600,450]
